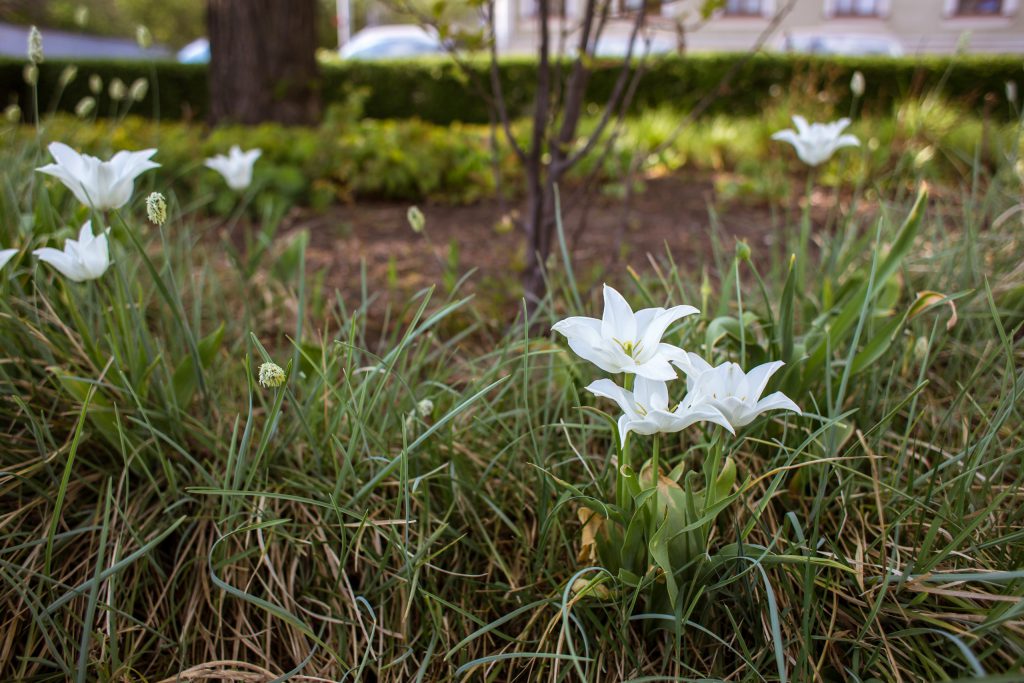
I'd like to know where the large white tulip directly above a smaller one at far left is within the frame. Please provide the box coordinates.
[36,142,160,211]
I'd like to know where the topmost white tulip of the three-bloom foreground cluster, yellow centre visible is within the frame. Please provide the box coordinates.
[551,285,698,381]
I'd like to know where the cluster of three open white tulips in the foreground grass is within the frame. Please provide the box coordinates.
[552,285,800,446]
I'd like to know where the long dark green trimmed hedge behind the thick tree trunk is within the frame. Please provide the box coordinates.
[0,54,1024,124]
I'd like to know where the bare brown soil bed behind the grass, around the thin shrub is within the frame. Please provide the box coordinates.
[286,174,802,319]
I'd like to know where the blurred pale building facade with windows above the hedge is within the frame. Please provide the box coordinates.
[495,0,1024,55]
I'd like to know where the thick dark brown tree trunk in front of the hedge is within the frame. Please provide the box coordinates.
[207,0,321,125]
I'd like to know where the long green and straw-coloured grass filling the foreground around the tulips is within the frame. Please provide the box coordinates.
[0,98,1024,682]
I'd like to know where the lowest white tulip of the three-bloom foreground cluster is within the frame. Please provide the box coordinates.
[587,377,732,446]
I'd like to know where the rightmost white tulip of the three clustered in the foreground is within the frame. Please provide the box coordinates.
[676,353,802,431]
